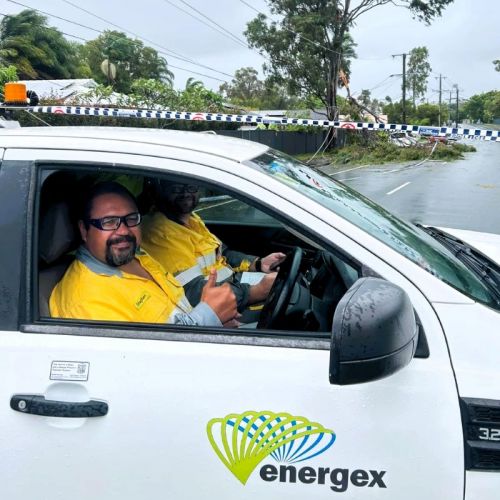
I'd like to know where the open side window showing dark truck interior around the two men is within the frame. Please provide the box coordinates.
[38,168,360,338]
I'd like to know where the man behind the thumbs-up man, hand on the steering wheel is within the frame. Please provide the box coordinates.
[143,180,286,321]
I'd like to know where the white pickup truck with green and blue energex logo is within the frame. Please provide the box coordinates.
[0,127,500,500]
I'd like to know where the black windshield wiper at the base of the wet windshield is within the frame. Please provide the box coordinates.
[416,224,500,299]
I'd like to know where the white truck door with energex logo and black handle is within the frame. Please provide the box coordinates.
[0,150,464,500]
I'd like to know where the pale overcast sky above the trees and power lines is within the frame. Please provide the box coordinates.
[0,0,500,101]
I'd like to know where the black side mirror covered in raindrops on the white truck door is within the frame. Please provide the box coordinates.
[330,278,418,385]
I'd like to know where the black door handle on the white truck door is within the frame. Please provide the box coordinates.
[10,394,108,418]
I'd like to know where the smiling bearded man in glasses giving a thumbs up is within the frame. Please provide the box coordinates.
[49,182,236,326]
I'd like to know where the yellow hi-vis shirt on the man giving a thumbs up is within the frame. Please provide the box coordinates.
[49,247,196,323]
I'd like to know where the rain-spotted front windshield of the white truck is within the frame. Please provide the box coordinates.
[246,150,499,309]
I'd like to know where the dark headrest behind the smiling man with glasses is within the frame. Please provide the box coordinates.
[39,201,77,264]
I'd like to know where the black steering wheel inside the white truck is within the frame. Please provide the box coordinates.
[257,247,302,328]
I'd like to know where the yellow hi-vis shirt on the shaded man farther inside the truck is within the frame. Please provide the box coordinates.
[142,212,250,285]
